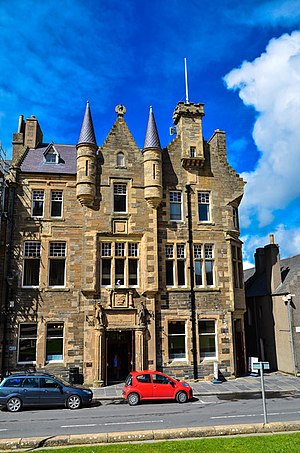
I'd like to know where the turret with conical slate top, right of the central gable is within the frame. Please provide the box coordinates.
[143,107,162,208]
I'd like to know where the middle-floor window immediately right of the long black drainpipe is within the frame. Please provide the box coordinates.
[194,244,215,286]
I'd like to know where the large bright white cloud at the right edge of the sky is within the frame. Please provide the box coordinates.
[225,31,300,227]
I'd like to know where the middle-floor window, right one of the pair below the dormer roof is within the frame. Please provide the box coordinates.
[49,242,66,286]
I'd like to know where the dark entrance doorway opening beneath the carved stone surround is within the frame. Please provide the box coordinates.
[106,330,135,384]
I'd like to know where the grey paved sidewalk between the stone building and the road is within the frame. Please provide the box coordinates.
[93,372,300,400]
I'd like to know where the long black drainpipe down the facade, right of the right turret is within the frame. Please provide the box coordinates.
[185,184,198,380]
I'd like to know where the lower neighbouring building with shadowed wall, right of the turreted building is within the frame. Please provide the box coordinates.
[244,234,300,375]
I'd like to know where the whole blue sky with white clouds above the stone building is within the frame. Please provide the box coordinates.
[0,0,300,266]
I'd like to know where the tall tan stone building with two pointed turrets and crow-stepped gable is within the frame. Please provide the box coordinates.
[4,102,245,385]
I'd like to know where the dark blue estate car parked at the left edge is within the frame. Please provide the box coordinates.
[0,373,93,412]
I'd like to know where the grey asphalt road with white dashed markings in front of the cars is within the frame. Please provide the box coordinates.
[0,395,300,439]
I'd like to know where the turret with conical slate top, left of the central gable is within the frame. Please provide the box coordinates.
[76,102,98,206]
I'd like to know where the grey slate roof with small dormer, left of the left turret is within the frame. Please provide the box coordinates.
[21,143,77,175]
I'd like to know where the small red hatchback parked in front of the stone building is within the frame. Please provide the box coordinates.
[122,370,193,406]
